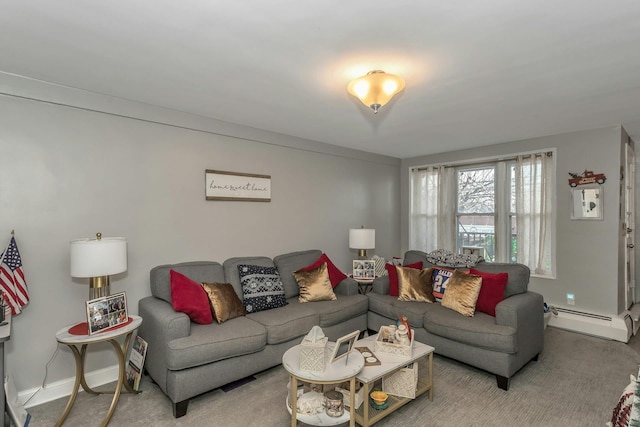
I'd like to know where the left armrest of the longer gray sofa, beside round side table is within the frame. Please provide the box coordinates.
[138,296,191,391]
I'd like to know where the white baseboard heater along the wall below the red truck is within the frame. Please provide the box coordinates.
[549,307,633,343]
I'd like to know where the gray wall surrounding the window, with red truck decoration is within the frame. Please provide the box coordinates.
[400,126,623,314]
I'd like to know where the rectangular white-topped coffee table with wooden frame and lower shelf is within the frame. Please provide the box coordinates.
[354,334,435,427]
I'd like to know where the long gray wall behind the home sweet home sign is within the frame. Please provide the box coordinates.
[0,75,400,391]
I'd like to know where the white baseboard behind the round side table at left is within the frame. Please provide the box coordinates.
[18,365,118,408]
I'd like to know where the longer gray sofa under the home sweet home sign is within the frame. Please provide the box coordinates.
[138,250,368,418]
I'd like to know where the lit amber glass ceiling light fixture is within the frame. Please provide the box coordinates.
[347,70,404,114]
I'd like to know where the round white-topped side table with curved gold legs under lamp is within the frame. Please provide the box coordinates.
[56,315,142,427]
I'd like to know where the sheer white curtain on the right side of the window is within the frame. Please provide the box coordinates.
[515,153,554,276]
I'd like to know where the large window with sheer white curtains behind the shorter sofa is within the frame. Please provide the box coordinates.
[410,152,555,276]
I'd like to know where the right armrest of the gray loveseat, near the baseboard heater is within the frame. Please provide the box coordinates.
[496,291,544,358]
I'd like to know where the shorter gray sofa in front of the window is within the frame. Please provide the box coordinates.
[367,251,544,390]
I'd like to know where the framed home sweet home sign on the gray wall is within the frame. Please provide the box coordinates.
[205,169,271,202]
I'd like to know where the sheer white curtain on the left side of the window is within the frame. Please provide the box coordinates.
[409,166,455,252]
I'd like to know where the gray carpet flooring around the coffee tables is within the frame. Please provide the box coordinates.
[23,327,640,427]
